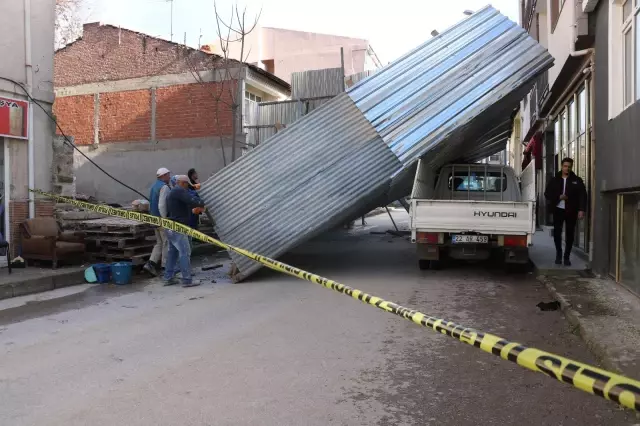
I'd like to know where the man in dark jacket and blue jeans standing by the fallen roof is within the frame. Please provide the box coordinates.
[164,175,204,287]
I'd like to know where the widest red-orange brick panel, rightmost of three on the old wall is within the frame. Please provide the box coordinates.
[156,83,232,139]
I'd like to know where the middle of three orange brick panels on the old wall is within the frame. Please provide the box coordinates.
[98,90,151,143]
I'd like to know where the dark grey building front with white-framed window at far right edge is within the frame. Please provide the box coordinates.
[592,0,640,295]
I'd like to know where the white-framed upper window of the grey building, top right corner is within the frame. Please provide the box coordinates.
[609,0,640,119]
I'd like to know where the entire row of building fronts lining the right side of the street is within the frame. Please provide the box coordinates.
[520,0,640,294]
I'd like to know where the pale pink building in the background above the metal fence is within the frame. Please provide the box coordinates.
[214,26,382,82]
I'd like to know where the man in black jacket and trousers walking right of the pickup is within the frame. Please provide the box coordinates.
[544,158,587,266]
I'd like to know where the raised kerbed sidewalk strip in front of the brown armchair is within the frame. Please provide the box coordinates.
[0,266,86,300]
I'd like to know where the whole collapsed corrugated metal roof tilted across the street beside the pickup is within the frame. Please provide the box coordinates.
[201,6,553,280]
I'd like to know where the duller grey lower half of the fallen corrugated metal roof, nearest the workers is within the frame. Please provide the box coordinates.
[201,94,401,279]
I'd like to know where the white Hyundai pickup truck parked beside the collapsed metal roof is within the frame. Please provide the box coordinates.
[410,162,535,269]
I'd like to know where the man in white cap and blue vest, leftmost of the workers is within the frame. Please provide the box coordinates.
[144,167,171,276]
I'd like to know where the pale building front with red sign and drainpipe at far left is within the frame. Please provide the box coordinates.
[0,0,55,255]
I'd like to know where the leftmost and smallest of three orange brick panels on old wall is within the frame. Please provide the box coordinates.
[53,95,94,145]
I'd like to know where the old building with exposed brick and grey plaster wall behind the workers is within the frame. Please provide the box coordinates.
[54,23,290,203]
